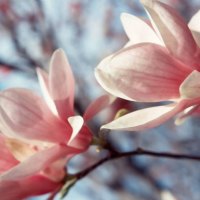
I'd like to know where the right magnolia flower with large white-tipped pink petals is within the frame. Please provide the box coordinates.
[95,0,200,131]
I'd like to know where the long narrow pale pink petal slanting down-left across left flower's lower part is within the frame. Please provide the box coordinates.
[0,145,79,181]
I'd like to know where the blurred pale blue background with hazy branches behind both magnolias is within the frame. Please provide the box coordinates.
[0,0,200,200]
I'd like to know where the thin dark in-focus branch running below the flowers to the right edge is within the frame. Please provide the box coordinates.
[73,148,200,180]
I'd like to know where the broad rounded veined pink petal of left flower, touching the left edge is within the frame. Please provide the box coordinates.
[0,88,71,143]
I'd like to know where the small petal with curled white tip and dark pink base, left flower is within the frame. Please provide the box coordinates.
[68,116,92,151]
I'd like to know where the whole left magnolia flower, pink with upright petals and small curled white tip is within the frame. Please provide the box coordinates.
[0,50,113,200]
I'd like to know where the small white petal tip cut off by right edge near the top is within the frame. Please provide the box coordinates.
[188,10,200,47]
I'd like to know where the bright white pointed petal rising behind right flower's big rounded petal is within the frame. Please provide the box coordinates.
[121,13,164,45]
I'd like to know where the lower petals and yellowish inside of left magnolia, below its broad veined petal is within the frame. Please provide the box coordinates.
[0,135,78,200]
